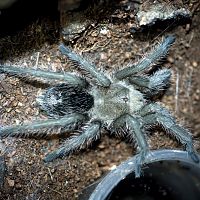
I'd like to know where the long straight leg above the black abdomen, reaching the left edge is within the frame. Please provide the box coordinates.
[0,65,88,88]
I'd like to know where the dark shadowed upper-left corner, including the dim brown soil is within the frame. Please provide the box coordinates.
[0,0,60,63]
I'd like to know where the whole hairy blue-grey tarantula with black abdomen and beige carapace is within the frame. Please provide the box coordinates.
[0,36,199,176]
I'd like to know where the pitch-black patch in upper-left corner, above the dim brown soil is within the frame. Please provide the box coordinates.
[0,0,59,37]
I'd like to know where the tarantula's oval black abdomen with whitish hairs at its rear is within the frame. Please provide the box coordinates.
[37,84,94,117]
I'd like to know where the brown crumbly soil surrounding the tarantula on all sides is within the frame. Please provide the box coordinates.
[0,1,200,200]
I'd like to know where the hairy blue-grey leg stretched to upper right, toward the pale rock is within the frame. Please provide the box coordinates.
[115,36,175,80]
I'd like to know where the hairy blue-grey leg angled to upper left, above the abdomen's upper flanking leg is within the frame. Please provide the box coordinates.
[59,44,111,87]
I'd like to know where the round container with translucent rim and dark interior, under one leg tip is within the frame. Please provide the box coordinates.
[79,150,200,200]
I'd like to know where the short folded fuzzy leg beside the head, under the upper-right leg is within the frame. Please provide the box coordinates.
[129,69,171,96]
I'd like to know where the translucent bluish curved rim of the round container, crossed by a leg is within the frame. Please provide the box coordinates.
[89,150,200,200]
